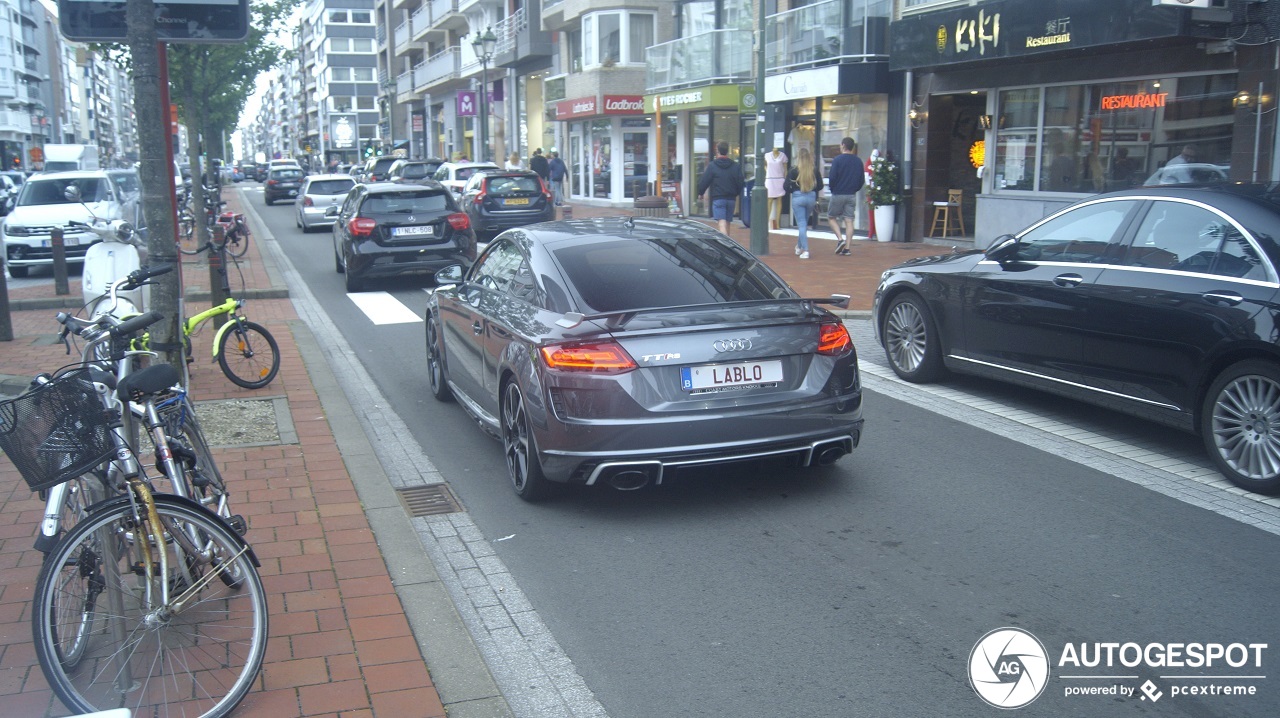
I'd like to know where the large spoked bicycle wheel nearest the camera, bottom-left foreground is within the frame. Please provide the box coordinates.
[32,495,268,718]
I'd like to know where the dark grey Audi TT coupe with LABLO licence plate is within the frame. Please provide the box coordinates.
[426,218,863,500]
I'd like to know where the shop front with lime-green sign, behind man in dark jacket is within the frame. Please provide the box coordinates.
[644,84,755,216]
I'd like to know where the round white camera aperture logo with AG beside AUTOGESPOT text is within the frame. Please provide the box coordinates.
[969,628,1048,708]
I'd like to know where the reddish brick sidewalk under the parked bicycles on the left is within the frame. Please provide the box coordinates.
[0,197,445,718]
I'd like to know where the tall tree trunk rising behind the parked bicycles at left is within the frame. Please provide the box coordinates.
[125,0,184,375]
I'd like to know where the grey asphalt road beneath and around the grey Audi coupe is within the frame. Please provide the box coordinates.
[248,185,1280,718]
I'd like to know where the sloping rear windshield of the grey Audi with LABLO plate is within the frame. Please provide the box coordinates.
[556,237,791,311]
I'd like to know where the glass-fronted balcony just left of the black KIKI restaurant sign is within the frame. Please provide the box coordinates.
[764,0,891,74]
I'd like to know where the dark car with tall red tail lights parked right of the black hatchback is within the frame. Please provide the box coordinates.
[462,170,556,237]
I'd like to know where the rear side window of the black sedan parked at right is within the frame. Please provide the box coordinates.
[1124,201,1267,279]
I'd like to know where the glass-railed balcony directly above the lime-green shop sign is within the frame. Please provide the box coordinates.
[645,29,754,92]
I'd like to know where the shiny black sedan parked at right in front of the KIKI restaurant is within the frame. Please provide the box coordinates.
[873,184,1280,494]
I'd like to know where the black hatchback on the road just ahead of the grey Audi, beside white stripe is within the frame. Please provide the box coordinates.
[325,182,476,292]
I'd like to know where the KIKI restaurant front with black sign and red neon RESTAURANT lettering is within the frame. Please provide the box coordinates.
[891,0,1275,247]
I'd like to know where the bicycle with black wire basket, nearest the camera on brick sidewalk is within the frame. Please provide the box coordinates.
[0,365,268,718]
